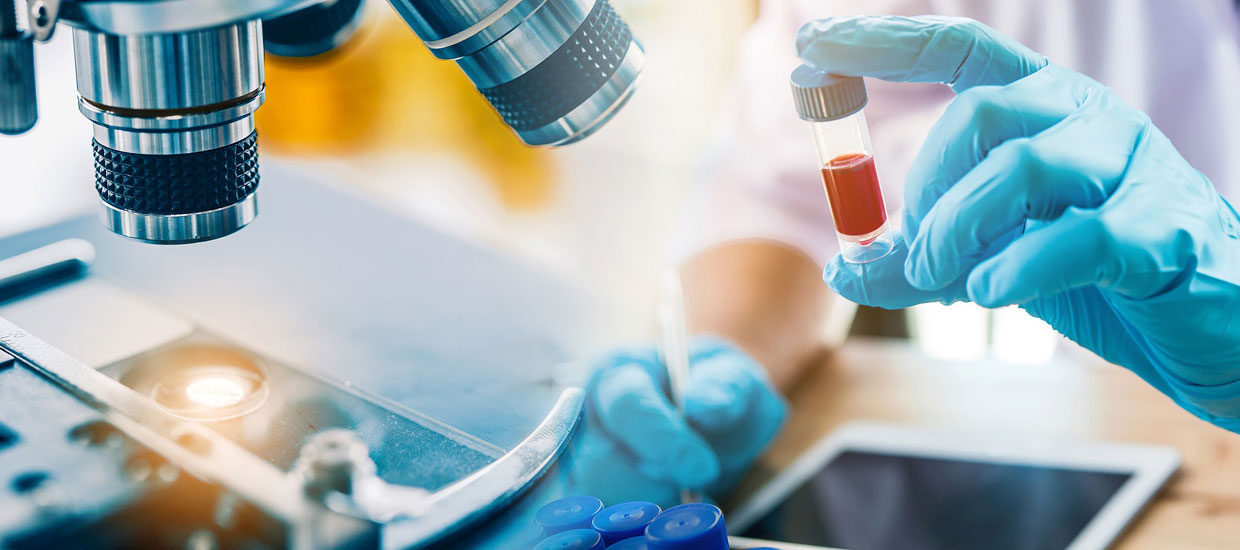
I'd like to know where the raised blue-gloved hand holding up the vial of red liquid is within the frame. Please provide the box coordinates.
[797,17,1240,431]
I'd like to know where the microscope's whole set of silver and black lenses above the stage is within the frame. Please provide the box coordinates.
[0,0,644,244]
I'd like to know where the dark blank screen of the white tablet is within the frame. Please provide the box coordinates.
[742,451,1131,550]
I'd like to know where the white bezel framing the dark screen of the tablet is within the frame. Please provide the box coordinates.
[728,421,1180,550]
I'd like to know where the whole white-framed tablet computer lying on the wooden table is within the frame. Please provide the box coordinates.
[728,422,1179,550]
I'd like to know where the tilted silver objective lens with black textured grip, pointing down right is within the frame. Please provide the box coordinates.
[389,0,645,145]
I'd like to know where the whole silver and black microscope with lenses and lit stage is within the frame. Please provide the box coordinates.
[0,0,644,550]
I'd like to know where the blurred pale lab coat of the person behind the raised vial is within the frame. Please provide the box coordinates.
[677,0,1240,264]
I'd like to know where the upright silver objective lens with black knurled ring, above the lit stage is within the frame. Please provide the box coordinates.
[73,20,263,244]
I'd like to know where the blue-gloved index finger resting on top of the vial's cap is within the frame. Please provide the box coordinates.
[796,16,1047,93]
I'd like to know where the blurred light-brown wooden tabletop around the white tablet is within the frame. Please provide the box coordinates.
[738,341,1240,550]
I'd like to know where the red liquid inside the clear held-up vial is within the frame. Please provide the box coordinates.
[822,154,887,245]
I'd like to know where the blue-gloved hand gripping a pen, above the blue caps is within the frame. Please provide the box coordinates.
[562,337,787,505]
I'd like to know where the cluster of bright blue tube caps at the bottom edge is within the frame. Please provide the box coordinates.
[517,495,775,550]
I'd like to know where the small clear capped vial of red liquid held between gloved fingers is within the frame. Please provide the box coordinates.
[791,64,894,264]
